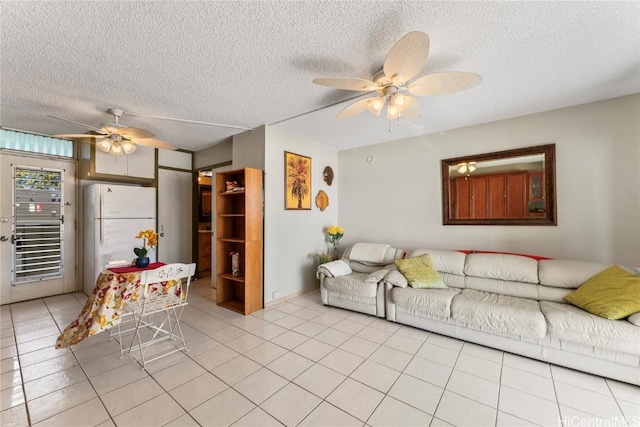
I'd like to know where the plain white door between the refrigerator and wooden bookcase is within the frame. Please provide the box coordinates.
[157,169,193,264]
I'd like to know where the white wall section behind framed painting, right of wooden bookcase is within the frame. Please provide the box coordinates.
[262,127,340,303]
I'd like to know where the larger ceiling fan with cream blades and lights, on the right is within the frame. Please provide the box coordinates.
[313,31,482,120]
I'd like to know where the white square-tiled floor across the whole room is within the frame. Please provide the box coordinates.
[0,280,640,427]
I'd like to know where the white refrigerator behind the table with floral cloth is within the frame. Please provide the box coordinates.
[84,184,156,295]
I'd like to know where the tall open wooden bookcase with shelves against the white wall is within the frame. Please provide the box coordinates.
[215,168,264,314]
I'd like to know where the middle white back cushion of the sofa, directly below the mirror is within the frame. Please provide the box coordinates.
[464,254,538,283]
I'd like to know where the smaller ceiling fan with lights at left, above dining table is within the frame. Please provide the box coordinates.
[47,108,176,156]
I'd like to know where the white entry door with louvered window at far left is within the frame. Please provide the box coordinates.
[0,153,77,304]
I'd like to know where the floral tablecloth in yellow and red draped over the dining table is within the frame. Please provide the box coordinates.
[56,270,182,348]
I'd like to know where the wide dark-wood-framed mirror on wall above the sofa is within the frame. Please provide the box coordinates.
[441,144,557,225]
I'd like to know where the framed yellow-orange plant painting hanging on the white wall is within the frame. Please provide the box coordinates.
[284,151,311,210]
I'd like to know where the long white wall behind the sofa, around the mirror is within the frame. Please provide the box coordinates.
[334,95,640,266]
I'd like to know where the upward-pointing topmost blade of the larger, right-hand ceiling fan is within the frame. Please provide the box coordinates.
[384,31,429,85]
